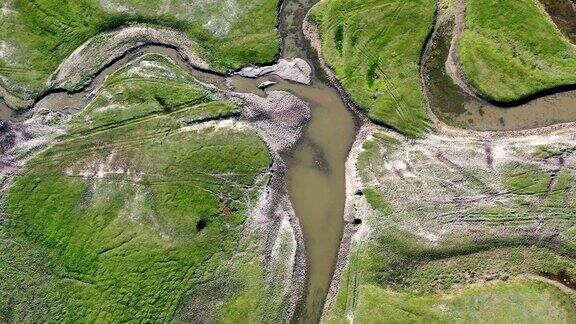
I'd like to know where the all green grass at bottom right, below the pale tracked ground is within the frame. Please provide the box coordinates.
[325,233,576,323]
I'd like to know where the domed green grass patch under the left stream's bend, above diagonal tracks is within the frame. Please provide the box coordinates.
[70,54,238,133]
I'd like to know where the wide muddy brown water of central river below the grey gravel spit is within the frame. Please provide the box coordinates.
[231,70,357,323]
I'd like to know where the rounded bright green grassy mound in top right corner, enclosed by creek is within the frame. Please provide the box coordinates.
[458,0,576,102]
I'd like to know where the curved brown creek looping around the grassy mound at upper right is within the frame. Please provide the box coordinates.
[422,0,576,131]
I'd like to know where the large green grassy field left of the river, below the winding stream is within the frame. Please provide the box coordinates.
[0,55,296,322]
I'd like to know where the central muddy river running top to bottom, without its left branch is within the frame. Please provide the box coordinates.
[280,0,358,323]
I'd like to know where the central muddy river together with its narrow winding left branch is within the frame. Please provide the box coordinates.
[0,0,358,323]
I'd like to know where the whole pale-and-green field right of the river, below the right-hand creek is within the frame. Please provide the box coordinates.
[328,132,576,323]
